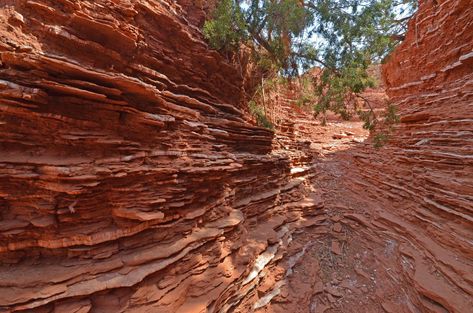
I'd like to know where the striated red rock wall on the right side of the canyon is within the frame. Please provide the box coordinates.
[347,0,473,312]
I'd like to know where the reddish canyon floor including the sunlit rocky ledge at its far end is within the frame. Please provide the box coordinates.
[237,115,418,313]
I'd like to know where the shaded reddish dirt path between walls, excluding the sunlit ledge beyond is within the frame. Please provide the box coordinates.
[270,146,409,313]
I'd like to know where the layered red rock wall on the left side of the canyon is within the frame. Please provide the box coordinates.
[0,0,321,312]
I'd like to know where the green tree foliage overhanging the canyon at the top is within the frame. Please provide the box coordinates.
[203,0,417,134]
